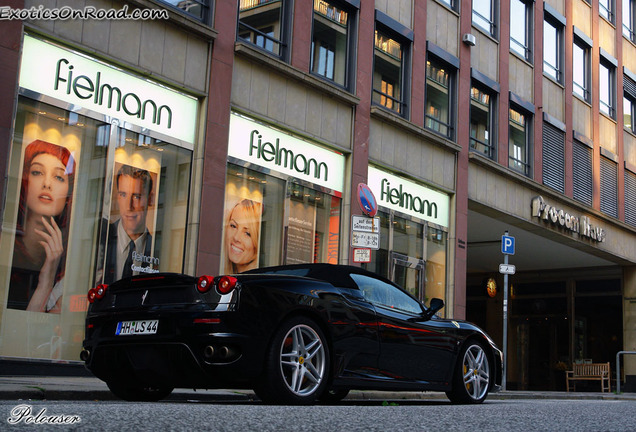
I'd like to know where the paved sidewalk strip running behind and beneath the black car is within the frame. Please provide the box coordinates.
[0,376,636,402]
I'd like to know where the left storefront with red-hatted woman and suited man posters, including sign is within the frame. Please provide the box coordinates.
[0,35,196,361]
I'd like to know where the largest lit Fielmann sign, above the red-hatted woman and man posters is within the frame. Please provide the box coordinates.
[20,35,198,144]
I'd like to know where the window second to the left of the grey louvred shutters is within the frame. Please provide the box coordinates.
[470,85,495,159]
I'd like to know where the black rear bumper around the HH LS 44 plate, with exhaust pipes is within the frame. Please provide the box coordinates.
[83,312,265,388]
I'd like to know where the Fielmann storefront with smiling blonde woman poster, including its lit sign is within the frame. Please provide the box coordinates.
[221,114,344,273]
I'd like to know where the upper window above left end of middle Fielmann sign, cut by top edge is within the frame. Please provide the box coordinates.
[238,0,290,60]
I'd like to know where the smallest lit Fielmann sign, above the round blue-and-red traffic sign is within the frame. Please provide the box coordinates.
[367,166,450,227]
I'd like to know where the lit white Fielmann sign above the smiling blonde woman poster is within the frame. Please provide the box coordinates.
[228,113,345,196]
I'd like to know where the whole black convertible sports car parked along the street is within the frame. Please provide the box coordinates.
[81,264,502,404]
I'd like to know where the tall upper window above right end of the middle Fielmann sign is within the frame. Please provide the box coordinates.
[311,0,355,87]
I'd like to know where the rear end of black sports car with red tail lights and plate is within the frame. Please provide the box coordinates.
[81,274,300,388]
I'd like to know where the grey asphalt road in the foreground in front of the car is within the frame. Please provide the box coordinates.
[0,399,636,432]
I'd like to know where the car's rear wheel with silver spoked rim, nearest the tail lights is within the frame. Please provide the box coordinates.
[254,316,329,405]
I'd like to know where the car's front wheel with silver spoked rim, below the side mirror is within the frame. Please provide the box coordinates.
[446,341,492,404]
